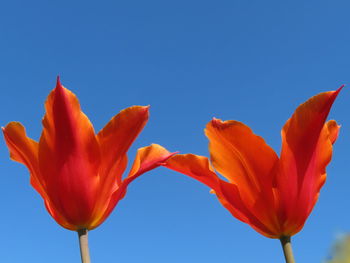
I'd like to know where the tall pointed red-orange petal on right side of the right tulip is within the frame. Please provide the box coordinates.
[276,88,341,235]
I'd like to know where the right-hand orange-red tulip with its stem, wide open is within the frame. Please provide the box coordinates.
[165,88,341,262]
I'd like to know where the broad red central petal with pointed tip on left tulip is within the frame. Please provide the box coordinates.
[39,80,100,228]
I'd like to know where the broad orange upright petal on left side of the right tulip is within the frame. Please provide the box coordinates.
[205,119,278,206]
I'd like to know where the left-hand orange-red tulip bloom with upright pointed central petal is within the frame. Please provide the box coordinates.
[3,78,172,262]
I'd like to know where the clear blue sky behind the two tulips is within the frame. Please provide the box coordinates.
[0,0,350,263]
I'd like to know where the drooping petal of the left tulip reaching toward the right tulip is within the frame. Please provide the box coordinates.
[92,144,176,228]
